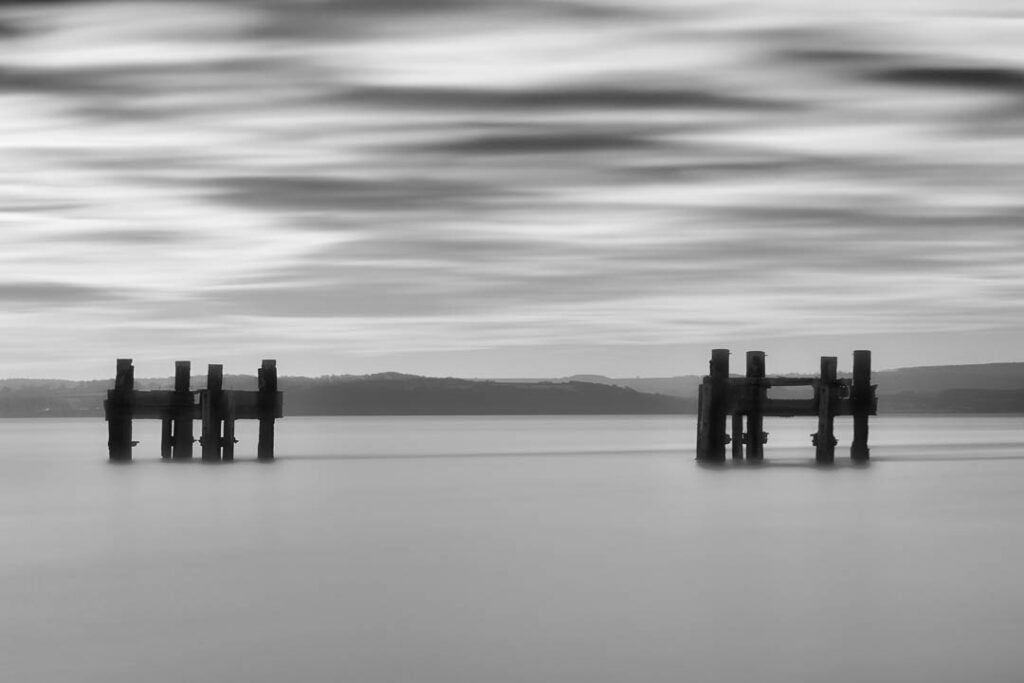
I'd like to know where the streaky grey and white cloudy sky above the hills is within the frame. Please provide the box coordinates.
[0,0,1024,379]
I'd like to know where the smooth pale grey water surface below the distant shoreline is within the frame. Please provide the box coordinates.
[0,417,1024,683]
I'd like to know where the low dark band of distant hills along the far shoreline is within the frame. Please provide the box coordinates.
[0,362,1024,417]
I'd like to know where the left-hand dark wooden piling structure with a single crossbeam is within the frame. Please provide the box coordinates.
[103,358,284,461]
